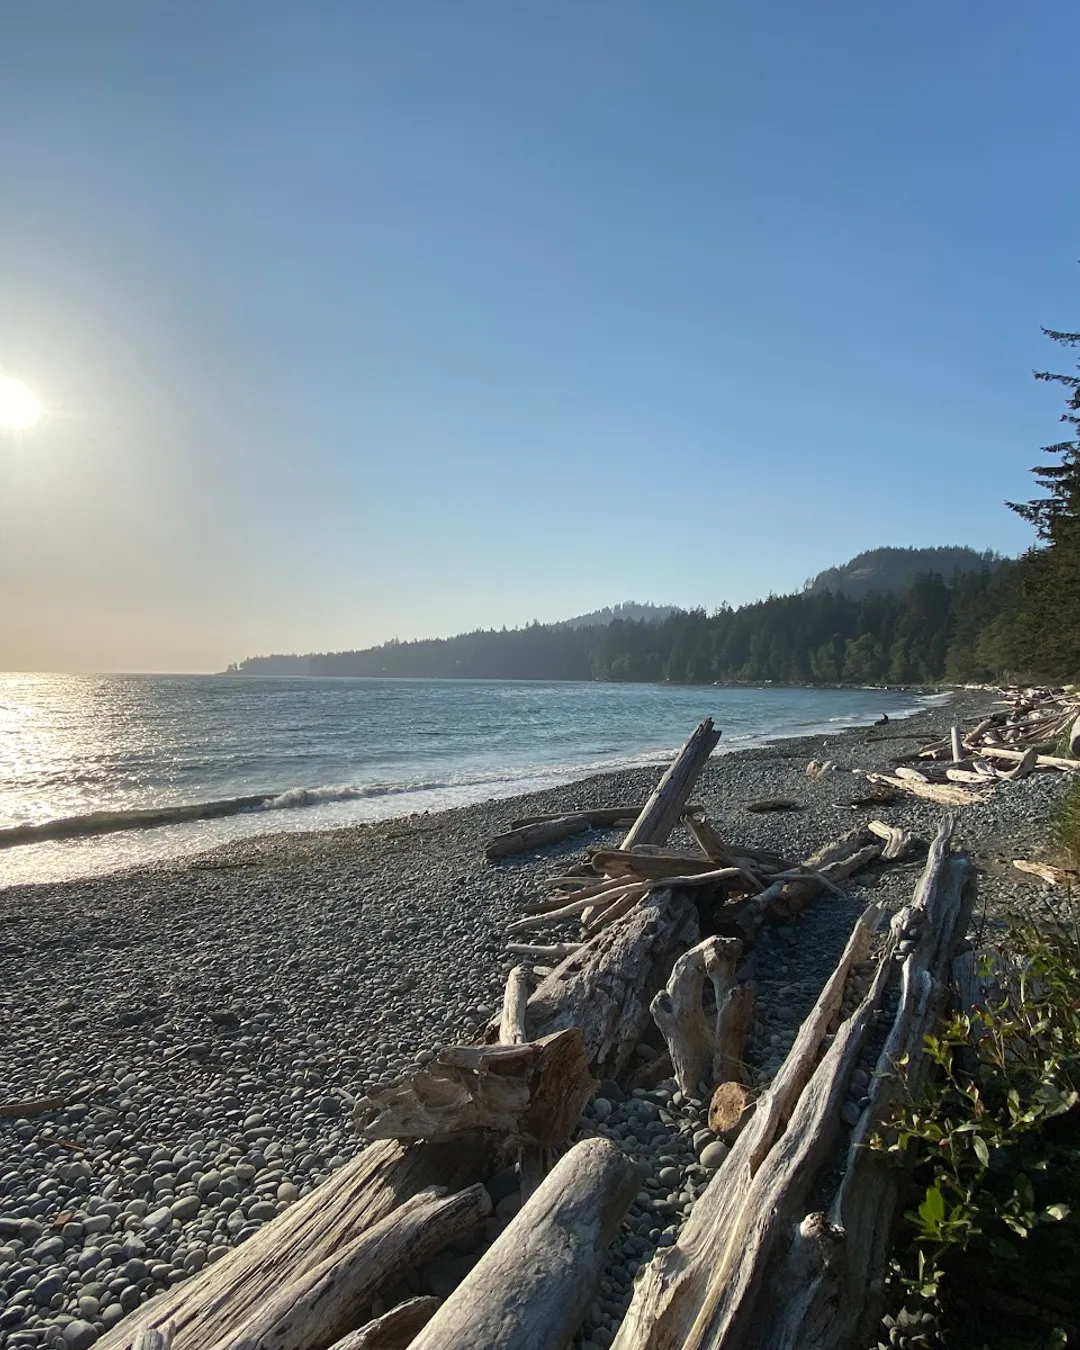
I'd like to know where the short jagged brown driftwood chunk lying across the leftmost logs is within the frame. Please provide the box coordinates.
[354,1026,597,1148]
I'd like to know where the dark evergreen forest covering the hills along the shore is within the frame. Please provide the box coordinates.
[232,314,1080,684]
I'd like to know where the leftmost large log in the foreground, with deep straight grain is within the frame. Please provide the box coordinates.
[97,1139,491,1350]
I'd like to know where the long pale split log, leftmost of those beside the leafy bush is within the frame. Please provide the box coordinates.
[613,906,882,1350]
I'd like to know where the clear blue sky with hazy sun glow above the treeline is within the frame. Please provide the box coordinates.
[0,0,1080,670]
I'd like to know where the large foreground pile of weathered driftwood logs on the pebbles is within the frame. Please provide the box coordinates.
[100,721,988,1350]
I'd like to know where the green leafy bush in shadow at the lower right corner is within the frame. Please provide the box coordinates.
[878,910,1080,1350]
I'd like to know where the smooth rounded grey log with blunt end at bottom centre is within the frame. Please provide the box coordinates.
[410,1139,640,1350]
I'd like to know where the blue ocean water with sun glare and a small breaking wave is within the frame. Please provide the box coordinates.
[0,675,919,886]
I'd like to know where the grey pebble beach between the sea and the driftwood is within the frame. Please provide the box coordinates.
[0,694,1065,1350]
